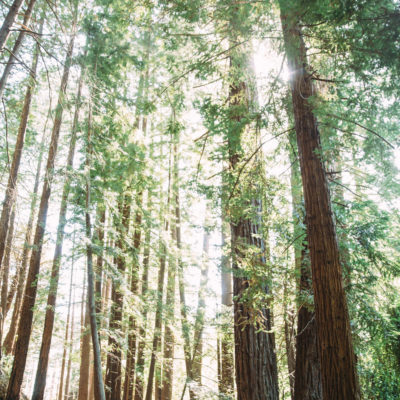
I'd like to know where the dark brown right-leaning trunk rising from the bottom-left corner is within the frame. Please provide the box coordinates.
[7,18,76,400]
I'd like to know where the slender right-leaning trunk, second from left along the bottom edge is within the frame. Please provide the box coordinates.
[32,62,83,400]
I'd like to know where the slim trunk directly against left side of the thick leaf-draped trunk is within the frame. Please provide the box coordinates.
[219,214,235,396]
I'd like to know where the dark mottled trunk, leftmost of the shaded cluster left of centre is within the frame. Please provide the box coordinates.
[106,195,131,400]
